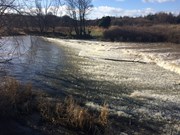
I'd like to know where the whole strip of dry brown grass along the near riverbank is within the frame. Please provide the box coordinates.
[0,77,108,134]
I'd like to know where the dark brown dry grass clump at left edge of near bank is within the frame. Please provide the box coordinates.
[0,77,32,116]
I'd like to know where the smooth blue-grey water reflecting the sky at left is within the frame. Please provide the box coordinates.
[1,36,68,95]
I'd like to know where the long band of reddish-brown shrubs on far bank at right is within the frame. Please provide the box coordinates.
[103,24,180,43]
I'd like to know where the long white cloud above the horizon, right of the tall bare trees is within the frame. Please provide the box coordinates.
[88,6,155,19]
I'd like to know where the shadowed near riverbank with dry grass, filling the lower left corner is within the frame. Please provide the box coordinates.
[0,77,108,135]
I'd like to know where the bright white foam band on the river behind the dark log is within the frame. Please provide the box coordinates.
[46,38,180,74]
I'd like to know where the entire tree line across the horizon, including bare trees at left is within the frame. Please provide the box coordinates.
[0,0,180,38]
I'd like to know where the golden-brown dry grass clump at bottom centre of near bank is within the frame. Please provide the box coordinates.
[39,96,108,134]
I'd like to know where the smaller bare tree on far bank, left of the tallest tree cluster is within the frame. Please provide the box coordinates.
[24,0,61,33]
